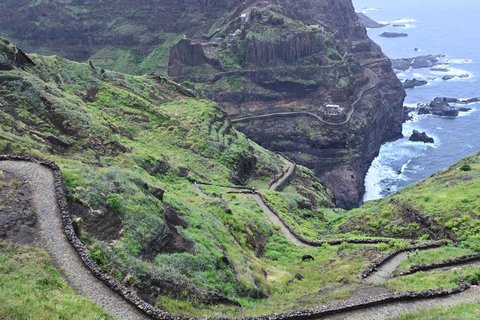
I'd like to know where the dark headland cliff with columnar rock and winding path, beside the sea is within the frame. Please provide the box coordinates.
[169,0,404,208]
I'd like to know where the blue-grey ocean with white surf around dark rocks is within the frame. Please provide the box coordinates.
[353,0,480,201]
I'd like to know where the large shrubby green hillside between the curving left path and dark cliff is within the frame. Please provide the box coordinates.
[0,36,386,315]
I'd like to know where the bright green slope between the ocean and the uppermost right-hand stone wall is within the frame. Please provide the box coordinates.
[339,154,480,252]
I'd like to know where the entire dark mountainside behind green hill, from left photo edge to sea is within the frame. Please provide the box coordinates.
[0,0,404,208]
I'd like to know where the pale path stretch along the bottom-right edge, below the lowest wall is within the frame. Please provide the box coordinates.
[316,286,480,320]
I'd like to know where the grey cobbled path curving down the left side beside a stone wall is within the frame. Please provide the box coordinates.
[0,161,151,320]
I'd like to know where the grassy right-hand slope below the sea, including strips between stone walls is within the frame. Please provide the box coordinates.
[334,153,480,294]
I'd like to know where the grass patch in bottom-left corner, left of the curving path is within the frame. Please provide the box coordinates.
[0,242,111,320]
